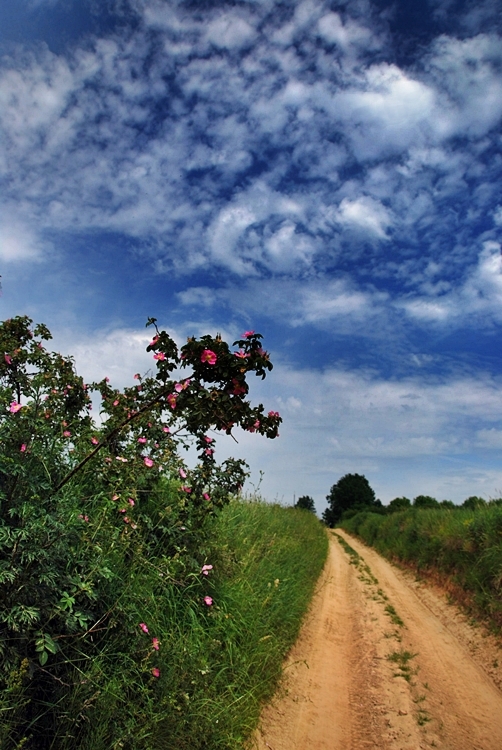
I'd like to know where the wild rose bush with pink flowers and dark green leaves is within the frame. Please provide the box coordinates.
[0,317,281,747]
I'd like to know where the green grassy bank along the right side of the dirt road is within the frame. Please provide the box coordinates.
[340,506,502,628]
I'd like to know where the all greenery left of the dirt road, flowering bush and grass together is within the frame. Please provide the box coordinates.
[0,317,327,750]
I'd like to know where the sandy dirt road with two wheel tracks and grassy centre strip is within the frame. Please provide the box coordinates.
[254,529,502,750]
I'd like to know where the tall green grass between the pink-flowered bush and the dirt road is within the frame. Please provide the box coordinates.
[0,501,327,750]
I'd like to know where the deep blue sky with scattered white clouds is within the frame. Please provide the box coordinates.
[0,0,502,512]
